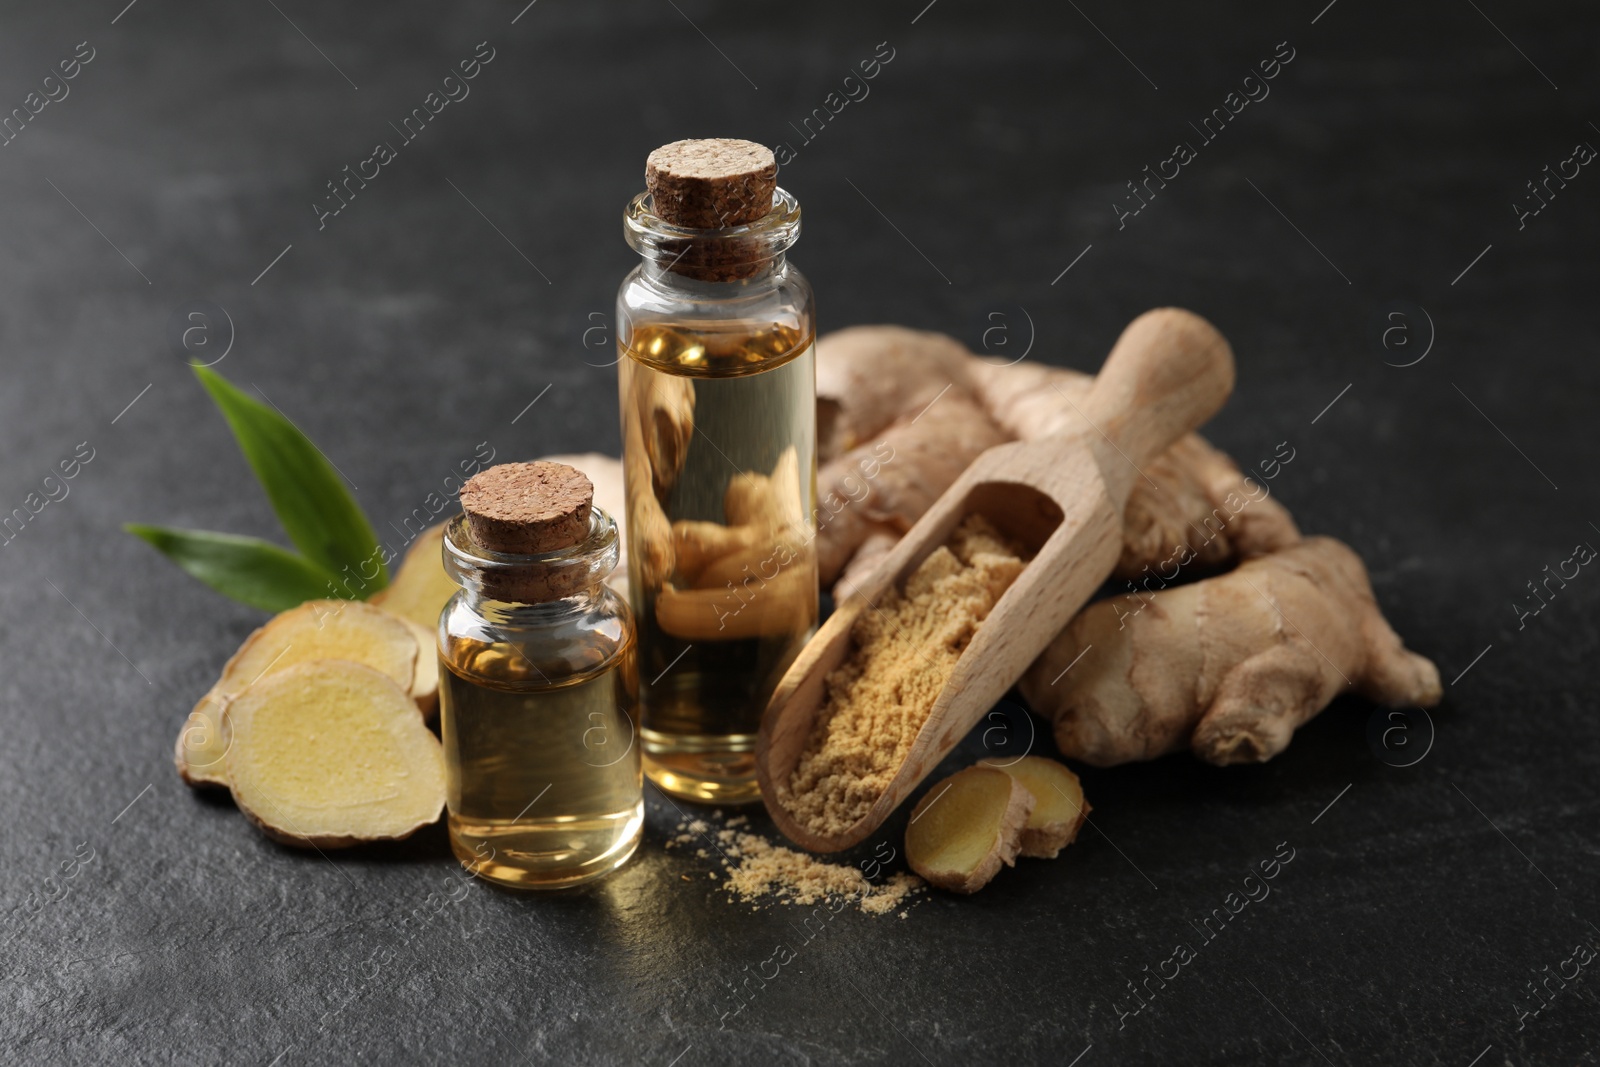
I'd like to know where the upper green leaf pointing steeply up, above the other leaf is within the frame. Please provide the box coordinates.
[195,366,389,595]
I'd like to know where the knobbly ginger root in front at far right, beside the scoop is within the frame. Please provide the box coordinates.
[1021,537,1442,766]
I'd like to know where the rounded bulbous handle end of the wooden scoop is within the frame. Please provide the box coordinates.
[1083,307,1234,467]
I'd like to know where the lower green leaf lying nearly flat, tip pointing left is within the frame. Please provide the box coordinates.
[123,523,341,611]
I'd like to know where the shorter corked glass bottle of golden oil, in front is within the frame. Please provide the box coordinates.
[438,462,645,888]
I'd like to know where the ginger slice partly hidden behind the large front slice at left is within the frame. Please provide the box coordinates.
[173,600,419,785]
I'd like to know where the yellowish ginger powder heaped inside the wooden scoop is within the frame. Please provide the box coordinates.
[778,515,1026,835]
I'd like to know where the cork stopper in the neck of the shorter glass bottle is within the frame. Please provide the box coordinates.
[461,461,595,603]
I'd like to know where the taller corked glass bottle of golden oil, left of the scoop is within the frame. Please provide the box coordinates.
[618,141,818,803]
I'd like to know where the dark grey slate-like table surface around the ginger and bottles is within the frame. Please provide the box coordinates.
[0,0,1600,1067]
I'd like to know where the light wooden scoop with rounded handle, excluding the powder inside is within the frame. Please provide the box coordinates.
[755,307,1234,853]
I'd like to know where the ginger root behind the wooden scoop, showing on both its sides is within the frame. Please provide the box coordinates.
[816,326,1299,595]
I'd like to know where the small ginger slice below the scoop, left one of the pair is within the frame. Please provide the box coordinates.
[906,766,1034,893]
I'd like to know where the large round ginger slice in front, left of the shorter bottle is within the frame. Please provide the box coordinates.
[224,659,445,848]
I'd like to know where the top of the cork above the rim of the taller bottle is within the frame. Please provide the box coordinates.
[645,138,778,230]
